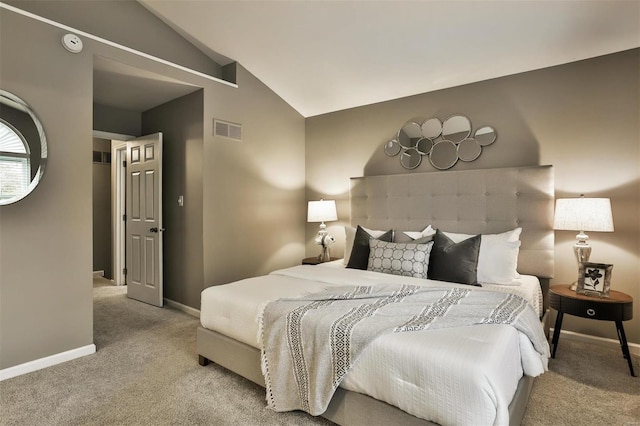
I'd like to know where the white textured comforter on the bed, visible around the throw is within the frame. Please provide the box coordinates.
[200,266,547,425]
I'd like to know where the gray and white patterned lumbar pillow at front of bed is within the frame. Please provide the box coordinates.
[367,239,433,279]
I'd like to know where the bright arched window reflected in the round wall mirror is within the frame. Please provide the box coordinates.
[0,119,31,199]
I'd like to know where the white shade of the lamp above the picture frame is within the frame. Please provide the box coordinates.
[553,197,613,232]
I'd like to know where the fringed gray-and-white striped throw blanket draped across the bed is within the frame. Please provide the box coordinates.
[261,285,549,415]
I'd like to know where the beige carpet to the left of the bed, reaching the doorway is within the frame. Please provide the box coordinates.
[0,284,330,425]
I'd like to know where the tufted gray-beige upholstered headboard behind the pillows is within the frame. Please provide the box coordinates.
[351,166,554,278]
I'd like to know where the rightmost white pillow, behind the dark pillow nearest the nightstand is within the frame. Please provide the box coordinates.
[442,228,522,285]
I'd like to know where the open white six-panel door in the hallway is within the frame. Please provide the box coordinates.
[126,133,164,306]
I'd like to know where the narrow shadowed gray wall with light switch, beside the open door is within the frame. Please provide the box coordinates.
[142,90,204,309]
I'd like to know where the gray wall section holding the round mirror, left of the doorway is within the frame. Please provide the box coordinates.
[0,10,93,368]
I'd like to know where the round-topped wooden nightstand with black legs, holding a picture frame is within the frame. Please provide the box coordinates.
[549,285,635,377]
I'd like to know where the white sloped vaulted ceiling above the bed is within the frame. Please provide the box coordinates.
[138,0,640,117]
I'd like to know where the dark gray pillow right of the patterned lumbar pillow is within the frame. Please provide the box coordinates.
[428,230,481,285]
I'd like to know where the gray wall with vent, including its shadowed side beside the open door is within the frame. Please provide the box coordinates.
[142,65,306,309]
